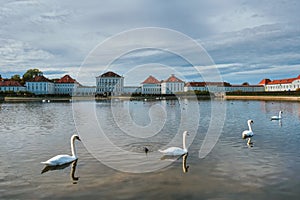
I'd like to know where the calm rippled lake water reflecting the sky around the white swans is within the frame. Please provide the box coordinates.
[0,100,300,199]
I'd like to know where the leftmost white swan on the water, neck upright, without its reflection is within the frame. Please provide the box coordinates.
[41,135,81,166]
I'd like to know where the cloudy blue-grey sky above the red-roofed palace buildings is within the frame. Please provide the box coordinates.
[0,0,300,85]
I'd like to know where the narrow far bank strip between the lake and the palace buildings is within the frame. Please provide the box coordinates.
[0,95,300,102]
